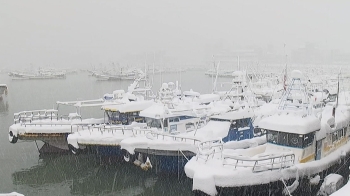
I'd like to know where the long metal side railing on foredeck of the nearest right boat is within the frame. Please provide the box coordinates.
[223,152,295,172]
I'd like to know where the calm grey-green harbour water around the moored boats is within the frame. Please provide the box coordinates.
[0,71,224,195]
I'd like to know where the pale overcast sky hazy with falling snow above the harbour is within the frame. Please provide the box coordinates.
[0,0,350,67]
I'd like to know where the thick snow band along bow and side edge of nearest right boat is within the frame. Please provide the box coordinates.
[185,139,350,195]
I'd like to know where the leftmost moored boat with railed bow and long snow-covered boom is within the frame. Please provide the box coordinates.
[9,74,151,150]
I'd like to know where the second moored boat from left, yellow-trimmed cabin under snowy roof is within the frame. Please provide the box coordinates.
[67,100,154,156]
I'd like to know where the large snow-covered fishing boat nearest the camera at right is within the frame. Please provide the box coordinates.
[185,70,350,195]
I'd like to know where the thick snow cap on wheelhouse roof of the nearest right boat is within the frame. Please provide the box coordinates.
[259,111,321,134]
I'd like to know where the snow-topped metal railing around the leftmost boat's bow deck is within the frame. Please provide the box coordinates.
[14,109,82,125]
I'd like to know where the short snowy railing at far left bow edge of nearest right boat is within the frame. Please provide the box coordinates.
[196,138,224,162]
